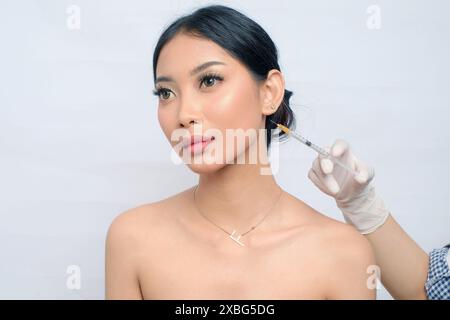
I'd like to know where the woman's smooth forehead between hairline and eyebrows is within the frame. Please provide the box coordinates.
[156,33,239,76]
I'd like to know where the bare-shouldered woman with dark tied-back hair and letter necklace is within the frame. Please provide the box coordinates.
[106,5,376,299]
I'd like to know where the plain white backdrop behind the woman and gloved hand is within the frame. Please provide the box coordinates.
[0,0,450,299]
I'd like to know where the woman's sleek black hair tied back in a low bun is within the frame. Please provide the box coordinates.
[153,5,295,149]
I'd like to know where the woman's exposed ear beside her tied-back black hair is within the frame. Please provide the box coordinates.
[260,69,284,116]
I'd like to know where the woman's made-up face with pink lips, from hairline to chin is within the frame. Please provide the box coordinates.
[155,34,274,173]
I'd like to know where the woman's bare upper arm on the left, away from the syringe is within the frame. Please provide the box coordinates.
[105,210,143,299]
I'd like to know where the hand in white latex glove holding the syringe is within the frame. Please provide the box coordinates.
[308,139,389,234]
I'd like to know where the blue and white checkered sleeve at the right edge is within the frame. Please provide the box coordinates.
[425,244,450,300]
